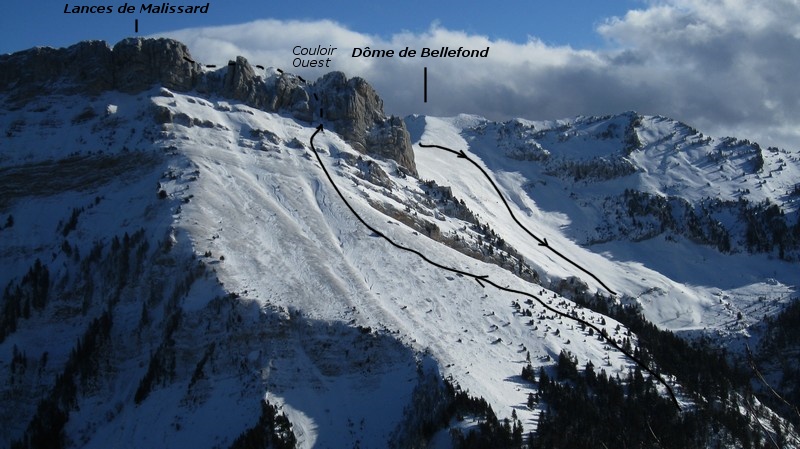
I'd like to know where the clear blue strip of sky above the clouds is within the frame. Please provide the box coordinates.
[0,0,644,53]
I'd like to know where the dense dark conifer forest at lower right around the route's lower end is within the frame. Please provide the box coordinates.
[522,295,800,448]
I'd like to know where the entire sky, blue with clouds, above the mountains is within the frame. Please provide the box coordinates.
[0,0,800,150]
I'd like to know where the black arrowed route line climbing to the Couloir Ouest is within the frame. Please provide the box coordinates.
[310,124,681,411]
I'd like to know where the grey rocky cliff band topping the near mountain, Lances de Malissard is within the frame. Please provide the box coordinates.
[0,38,416,174]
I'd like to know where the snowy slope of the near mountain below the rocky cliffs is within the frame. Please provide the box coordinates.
[1,86,668,447]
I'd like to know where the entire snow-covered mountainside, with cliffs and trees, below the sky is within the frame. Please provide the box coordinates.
[0,39,800,448]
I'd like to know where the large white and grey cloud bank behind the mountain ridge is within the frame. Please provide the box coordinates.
[155,0,800,149]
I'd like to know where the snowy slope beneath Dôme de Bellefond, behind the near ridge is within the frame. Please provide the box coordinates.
[407,114,800,331]
